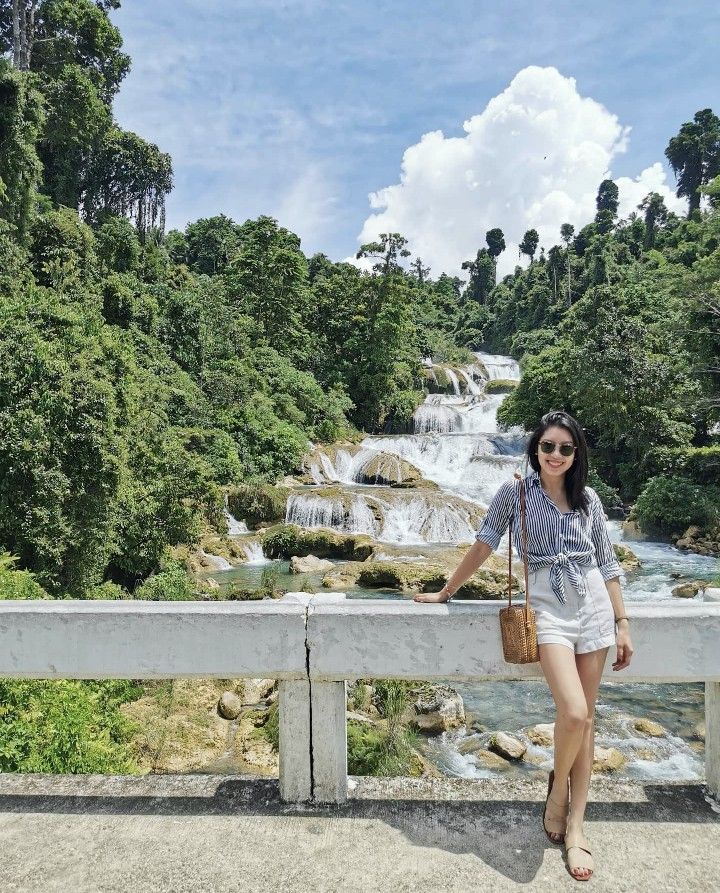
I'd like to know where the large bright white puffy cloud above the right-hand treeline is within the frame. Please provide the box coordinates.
[359,66,685,276]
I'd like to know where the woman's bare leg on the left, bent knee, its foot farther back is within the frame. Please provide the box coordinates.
[538,644,588,841]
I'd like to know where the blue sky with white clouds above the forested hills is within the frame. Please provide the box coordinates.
[111,0,720,277]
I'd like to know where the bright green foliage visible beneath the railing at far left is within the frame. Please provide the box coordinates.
[0,679,141,775]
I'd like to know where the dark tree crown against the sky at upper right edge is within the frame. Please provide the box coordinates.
[665,109,720,217]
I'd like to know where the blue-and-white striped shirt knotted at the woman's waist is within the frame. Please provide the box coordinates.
[475,469,620,604]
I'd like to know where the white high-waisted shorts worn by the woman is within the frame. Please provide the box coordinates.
[528,563,615,654]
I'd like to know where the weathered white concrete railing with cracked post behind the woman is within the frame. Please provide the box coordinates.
[0,593,720,803]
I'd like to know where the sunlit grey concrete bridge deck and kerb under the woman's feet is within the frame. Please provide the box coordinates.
[0,775,720,893]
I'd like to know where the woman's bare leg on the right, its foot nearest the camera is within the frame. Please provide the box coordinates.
[565,648,608,878]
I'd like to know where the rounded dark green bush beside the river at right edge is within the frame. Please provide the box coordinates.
[635,474,720,536]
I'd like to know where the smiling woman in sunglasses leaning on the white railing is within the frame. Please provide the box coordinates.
[415,412,633,881]
